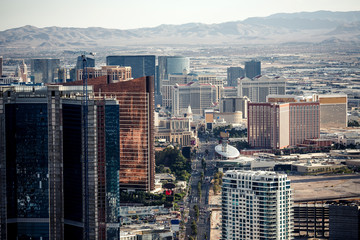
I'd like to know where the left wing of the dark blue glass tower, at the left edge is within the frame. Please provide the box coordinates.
[0,87,64,239]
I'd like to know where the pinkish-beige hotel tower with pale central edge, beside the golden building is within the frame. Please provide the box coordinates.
[248,102,320,149]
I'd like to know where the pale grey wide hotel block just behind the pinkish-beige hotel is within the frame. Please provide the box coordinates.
[238,76,286,102]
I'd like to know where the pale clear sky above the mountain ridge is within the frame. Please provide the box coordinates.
[0,0,360,30]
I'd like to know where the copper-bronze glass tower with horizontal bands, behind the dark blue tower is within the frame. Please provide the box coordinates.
[66,76,155,191]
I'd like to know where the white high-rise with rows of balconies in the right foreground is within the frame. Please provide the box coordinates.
[222,170,293,240]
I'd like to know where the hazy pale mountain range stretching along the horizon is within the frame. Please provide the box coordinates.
[0,11,360,49]
